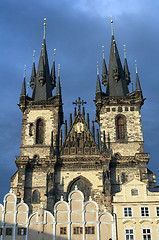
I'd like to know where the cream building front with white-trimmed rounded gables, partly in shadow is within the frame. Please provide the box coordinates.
[0,188,114,240]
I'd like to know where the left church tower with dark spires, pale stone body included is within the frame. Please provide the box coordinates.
[11,23,63,210]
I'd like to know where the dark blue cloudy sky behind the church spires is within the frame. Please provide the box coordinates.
[0,0,159,202]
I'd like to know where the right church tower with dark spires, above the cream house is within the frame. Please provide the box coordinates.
[95,20,155,194]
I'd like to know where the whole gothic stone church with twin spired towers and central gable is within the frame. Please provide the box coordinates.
[11,21,156,212]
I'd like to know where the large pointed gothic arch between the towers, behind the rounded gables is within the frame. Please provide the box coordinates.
[67,176,92,201]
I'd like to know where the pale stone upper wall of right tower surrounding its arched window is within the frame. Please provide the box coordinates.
[100,105,144,156]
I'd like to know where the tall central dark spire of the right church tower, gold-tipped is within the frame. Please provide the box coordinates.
[106,20,129,96]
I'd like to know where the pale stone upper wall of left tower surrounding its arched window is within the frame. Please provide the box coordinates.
[20,107,59,158]
